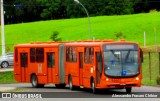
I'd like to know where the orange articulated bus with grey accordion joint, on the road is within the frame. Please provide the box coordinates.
[14,40,143,93]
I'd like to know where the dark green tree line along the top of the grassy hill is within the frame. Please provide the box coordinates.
[4,0,160,24]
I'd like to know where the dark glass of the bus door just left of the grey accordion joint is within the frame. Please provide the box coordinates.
[47,53,55,67]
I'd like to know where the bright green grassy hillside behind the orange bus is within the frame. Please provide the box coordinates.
[0,12,160,84]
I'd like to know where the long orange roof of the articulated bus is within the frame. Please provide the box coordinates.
[15,40,138,47]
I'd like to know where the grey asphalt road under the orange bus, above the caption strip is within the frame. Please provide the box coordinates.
[0,83,160,94]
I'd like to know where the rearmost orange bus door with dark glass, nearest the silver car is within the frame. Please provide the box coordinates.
[20,53,28,82]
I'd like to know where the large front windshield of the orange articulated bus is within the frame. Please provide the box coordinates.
[104,49,139,77]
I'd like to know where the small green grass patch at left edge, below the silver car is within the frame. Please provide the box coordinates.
[0,71,16,84]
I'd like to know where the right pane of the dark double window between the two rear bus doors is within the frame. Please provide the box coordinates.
[36,48,44,62]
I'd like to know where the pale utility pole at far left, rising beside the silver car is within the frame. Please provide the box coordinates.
[1,0,6,56]
